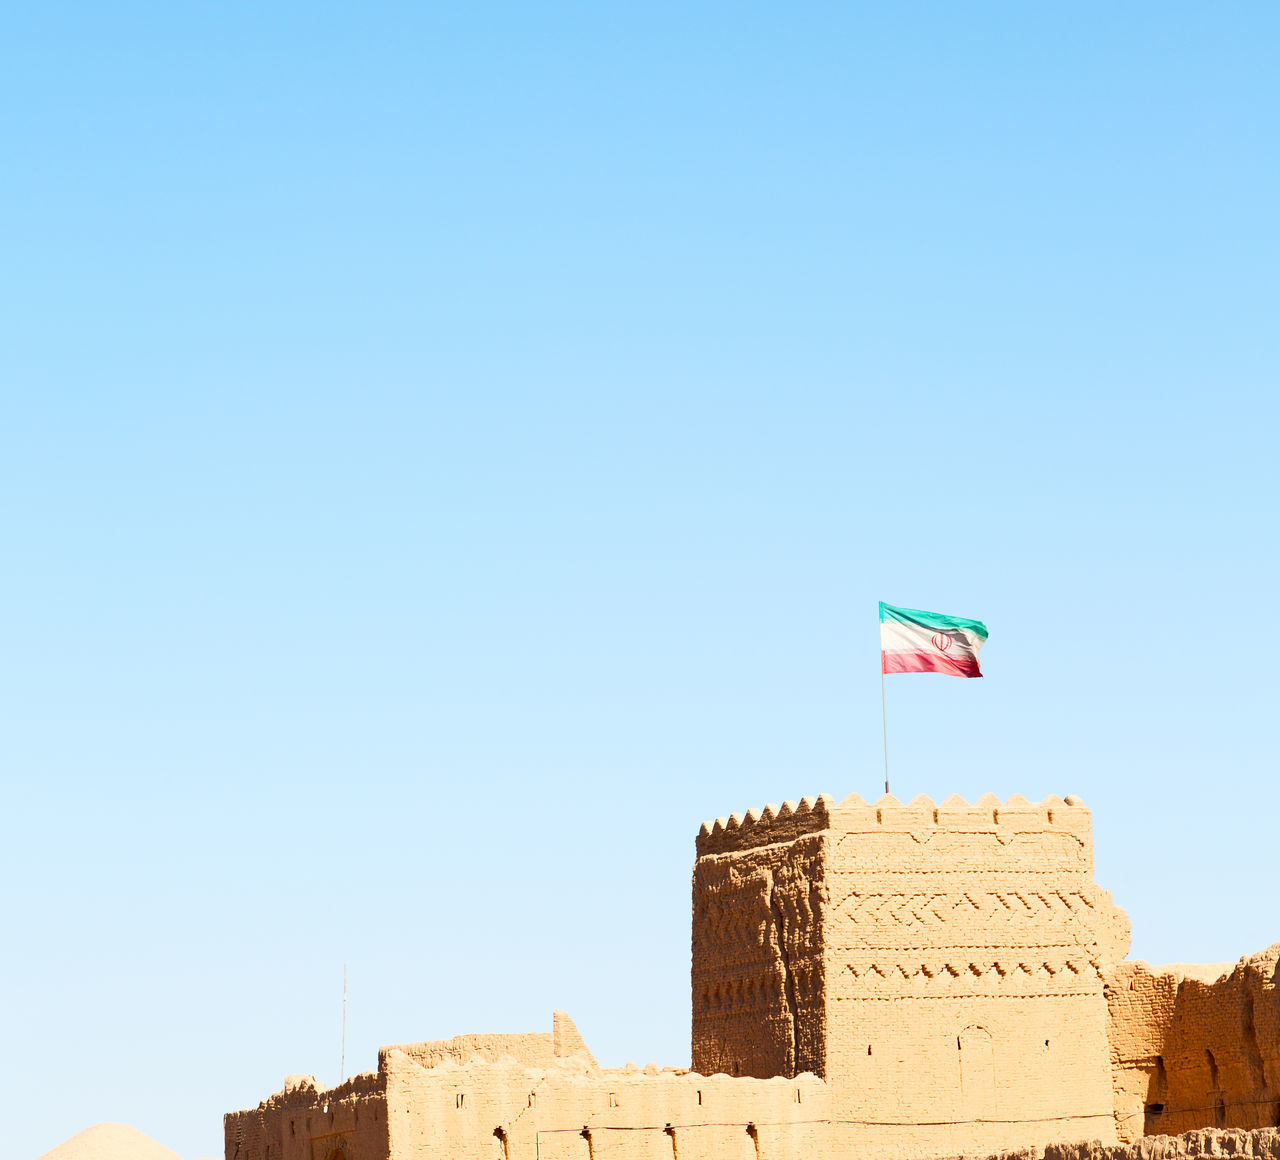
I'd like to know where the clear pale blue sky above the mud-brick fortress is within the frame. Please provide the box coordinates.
[0,0,1280,1157]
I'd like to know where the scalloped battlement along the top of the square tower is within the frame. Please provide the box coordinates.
[698,794,1091,858]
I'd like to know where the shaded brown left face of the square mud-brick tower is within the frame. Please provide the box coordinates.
[691,796,831,1078]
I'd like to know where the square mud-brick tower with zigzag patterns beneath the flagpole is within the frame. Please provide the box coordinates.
[692,795,1129,1156]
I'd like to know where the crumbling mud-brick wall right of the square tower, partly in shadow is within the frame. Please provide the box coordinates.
[1107,944,1280,1140]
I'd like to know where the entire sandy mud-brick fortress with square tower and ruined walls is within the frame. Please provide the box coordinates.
[225,795,1280,1160]
